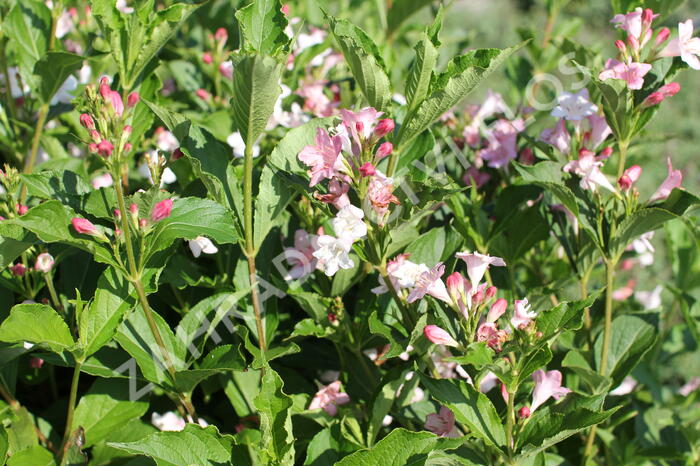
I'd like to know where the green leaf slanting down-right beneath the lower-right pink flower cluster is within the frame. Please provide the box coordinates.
[420,374,506,447]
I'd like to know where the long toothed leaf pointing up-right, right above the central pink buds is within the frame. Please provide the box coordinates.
[397,43,524,145]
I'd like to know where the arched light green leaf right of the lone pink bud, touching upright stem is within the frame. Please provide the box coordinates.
[150,197,238,253]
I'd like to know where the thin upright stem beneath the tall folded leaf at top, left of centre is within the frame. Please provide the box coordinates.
[243,142,267,354]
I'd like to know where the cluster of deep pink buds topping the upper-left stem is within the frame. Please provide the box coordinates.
[80,76,141,163]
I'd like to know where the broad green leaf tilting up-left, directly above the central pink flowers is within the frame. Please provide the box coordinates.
[329,18,392,111]
